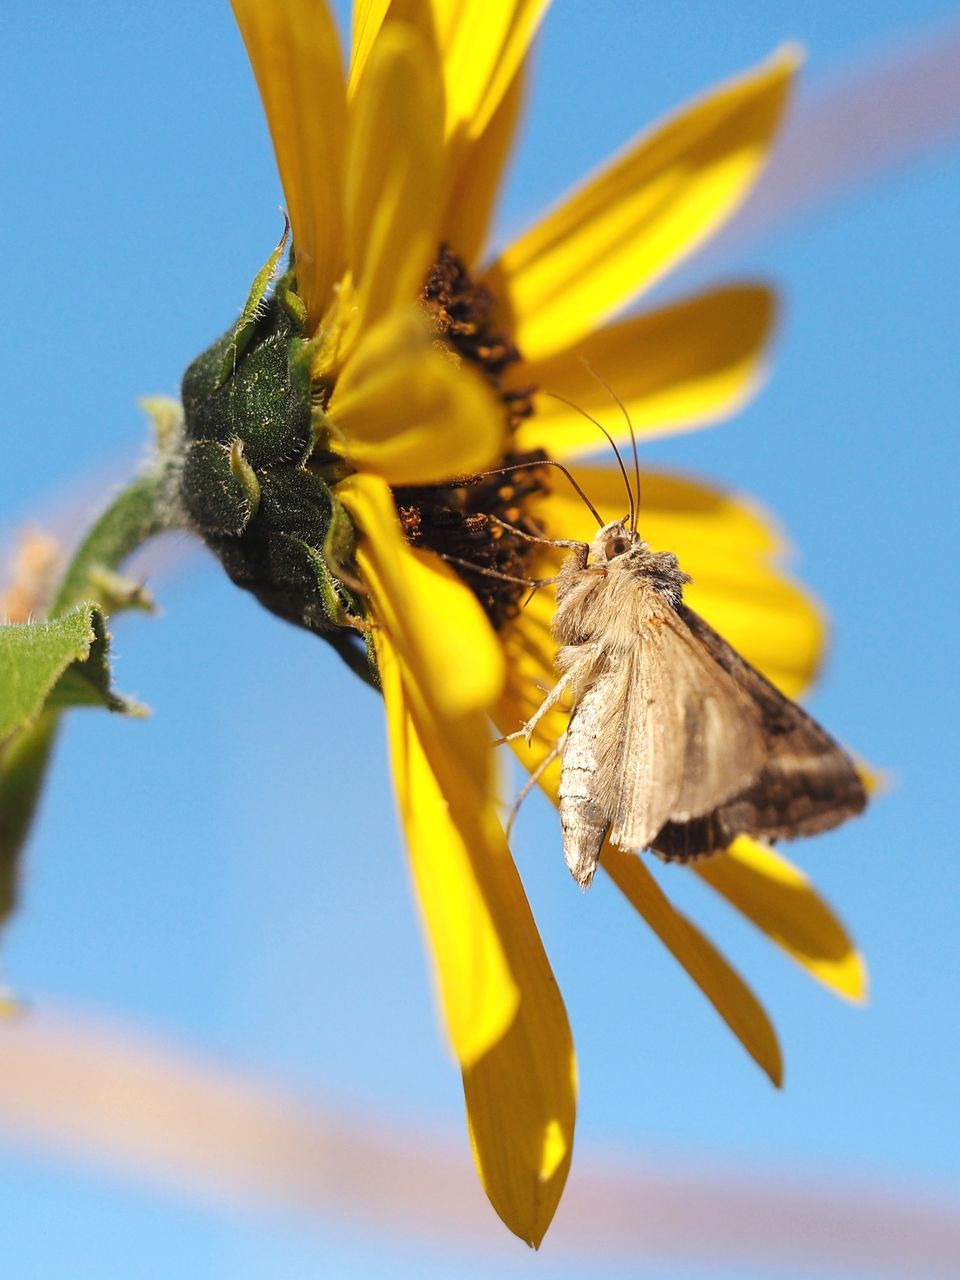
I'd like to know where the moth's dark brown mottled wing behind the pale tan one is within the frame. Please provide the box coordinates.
[653,605,867,858]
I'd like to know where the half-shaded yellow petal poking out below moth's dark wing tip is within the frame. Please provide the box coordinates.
[694,836,867,1002]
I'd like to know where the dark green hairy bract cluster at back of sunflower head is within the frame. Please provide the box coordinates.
[179,264,376,684]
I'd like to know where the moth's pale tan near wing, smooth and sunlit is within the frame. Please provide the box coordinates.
[598,598,764,849]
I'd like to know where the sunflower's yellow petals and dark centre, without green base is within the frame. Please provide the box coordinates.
[233,0,865,1244]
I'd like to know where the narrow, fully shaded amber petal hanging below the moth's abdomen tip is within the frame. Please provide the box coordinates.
[600,845,783,1085]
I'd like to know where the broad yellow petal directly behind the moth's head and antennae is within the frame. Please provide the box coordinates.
[531,466,826,698]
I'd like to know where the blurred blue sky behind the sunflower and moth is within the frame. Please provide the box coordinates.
[0,0,960,1280]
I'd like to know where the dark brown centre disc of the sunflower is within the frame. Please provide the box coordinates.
[393,244,547,630]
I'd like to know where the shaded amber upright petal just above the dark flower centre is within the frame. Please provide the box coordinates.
[440,70,524,266]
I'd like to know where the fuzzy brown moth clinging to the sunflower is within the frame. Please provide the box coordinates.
[509,519,867,887]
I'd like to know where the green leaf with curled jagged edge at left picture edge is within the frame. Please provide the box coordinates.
[0,604,143,742]
